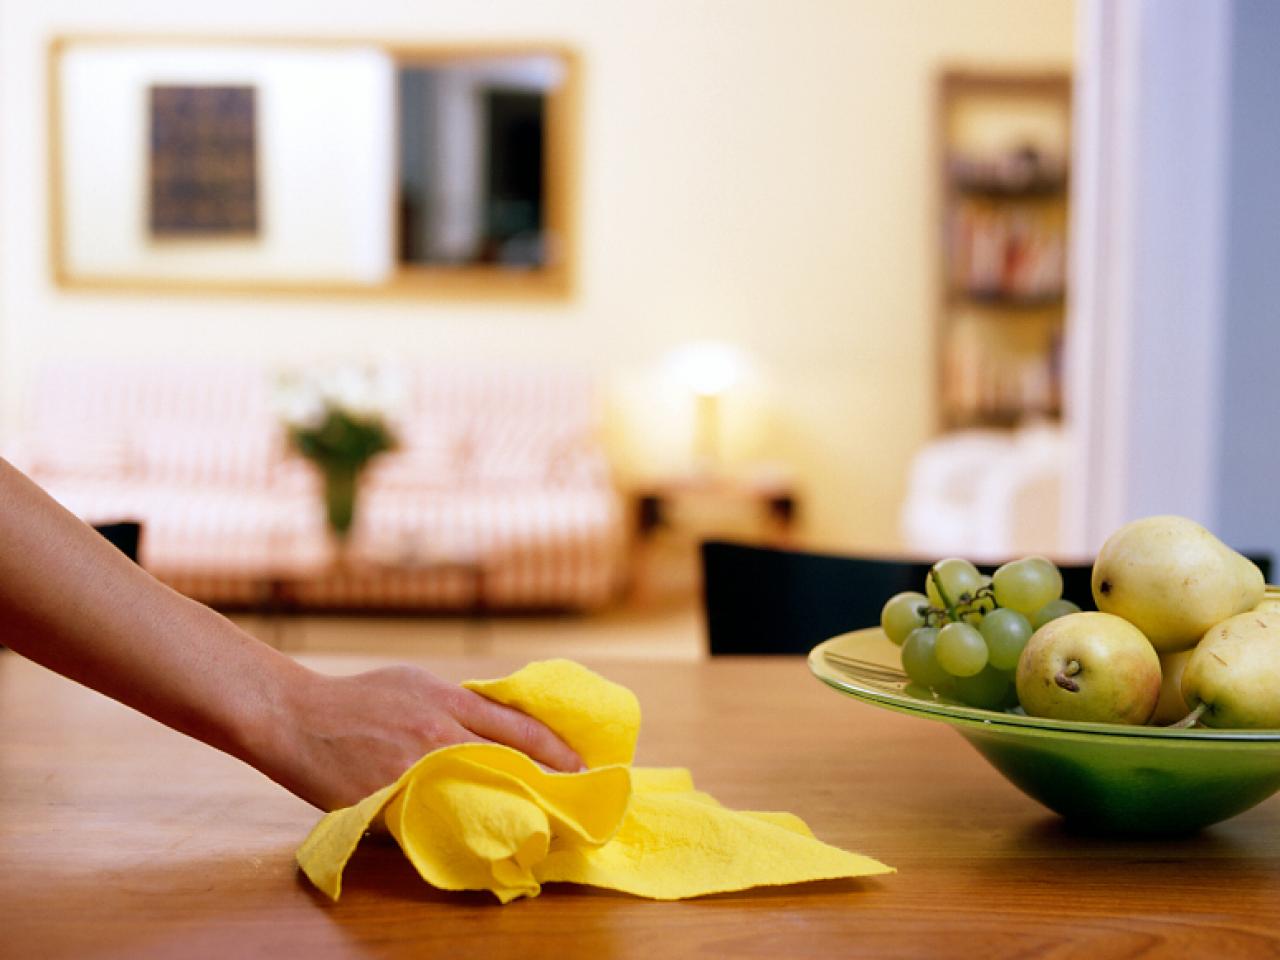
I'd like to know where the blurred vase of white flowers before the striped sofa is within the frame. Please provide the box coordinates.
[280,367,396,547]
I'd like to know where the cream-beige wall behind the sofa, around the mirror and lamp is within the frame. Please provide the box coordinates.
[0,0,1073,549]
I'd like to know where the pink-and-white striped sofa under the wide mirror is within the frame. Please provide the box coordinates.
[5,362,623,609]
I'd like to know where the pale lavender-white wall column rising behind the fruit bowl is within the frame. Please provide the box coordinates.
[1065,0,1233,553]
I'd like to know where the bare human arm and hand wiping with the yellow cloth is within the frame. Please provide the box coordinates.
[0,460,581,809]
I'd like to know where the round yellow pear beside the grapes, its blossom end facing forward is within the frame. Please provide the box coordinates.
[1015,612,1161,723]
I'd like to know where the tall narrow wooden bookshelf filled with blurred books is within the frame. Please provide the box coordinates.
[936,70,1071,430]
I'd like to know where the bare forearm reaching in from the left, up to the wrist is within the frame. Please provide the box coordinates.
[0,460,306,762]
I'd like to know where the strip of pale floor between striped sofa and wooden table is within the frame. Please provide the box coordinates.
[232,599,704,660]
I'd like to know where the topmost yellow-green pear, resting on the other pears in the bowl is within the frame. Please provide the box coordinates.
[1093,516,1266,653]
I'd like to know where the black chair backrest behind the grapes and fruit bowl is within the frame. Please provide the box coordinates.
[701,540,1096,655]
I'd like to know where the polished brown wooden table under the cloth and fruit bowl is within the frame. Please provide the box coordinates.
[0,653,1280,960]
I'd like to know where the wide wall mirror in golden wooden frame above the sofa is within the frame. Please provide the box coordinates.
[50,37,580,298]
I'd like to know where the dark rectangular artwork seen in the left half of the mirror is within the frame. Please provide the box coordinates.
[147,86,259,238]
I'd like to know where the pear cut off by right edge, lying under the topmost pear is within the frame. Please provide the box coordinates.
[1181,611,1280,728]
